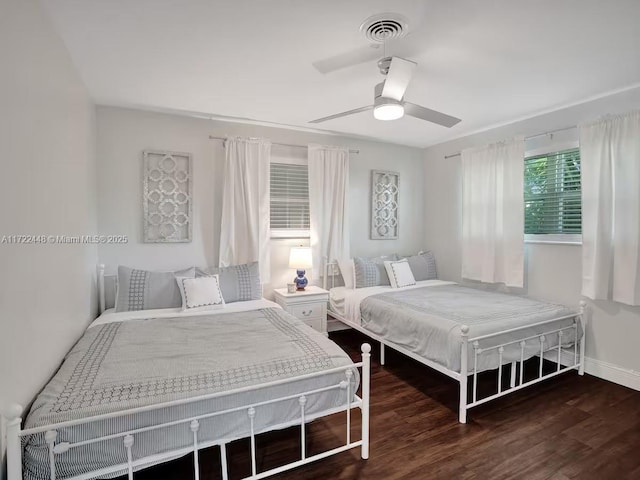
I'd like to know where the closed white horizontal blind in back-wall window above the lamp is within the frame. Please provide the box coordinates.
[271,163,310,230]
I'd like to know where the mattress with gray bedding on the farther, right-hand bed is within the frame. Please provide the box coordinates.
[332,280,582,373]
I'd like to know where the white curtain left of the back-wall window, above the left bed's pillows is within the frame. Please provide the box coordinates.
[220,138,271,283]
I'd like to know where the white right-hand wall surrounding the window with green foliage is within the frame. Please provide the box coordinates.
[424,88,640,389]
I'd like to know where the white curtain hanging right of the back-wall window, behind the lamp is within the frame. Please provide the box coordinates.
[308,145,349,280]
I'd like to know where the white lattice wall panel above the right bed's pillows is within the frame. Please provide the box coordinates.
[371,170,400,240]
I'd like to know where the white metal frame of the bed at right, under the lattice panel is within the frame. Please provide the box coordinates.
[323,259,586,423]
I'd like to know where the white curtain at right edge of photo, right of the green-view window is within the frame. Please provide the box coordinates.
[580,111,640,305]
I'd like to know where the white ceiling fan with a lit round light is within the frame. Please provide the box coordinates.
[309,57,461,128]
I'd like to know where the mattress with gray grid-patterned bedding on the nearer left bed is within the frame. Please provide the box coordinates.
[23,301,359,480]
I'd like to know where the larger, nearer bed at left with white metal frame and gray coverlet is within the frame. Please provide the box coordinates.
[8,266,370,480]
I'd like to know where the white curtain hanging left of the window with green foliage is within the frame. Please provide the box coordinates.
[462,137,524,287]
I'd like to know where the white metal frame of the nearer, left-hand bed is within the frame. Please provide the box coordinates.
[4,265,371,480]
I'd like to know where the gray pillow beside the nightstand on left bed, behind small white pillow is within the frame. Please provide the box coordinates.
[196,262,262,303]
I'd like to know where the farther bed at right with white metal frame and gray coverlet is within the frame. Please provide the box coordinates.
[324,263,585,423]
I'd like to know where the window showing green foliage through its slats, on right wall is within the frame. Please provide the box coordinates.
[524,148,582,239]
